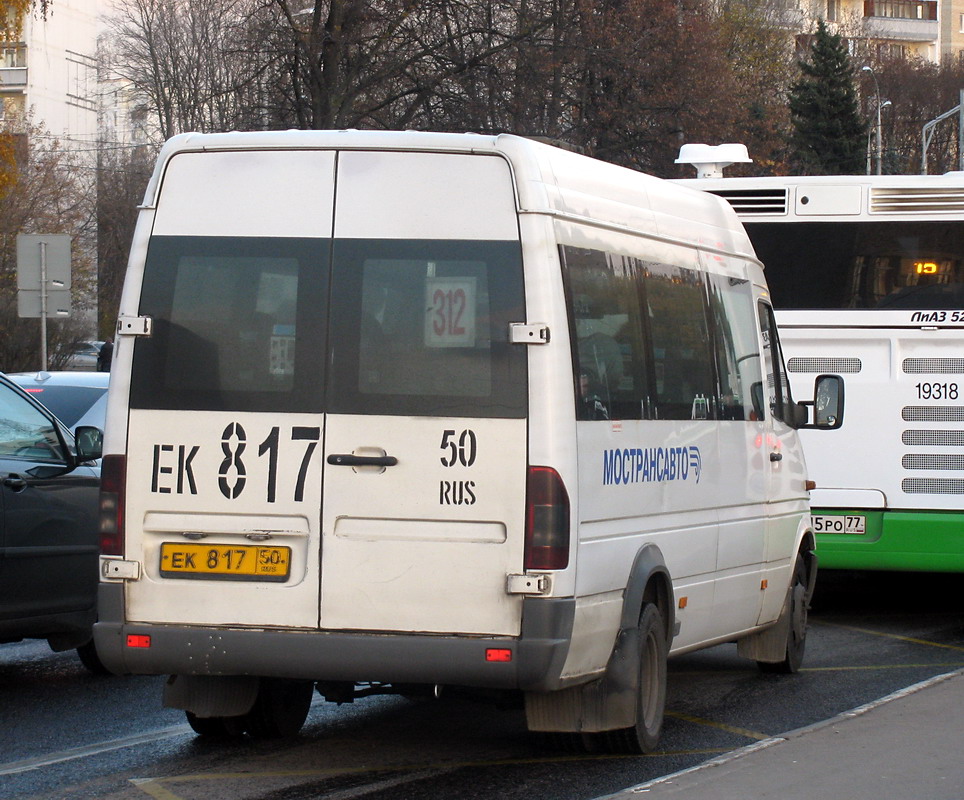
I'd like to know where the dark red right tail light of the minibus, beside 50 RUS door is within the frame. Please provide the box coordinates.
[525,467,569,570]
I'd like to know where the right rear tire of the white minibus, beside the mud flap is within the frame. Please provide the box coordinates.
[602,603,668,753]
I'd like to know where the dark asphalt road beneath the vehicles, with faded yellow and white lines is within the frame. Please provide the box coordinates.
[0,572,964,800]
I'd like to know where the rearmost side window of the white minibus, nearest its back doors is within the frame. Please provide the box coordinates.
[562,246,652,420]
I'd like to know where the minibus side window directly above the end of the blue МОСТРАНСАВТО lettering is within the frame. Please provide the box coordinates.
[643,262,716,419]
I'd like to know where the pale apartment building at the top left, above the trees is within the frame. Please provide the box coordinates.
[0,0,106,147]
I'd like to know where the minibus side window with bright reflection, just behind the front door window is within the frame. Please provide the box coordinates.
[709,275,766,420]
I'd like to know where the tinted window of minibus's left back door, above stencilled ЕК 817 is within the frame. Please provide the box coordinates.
[131,236,329,411]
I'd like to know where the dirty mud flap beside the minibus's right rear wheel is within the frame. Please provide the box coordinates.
[525,628,640,733]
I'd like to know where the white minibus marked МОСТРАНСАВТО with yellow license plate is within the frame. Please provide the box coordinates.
[95,131,841,752]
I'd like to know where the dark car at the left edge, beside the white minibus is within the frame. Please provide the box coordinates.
[0,375,101,671]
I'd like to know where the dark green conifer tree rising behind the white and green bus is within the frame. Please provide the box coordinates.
[790,20,867,175]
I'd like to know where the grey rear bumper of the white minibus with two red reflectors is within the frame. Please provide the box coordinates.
[94,584,574,691]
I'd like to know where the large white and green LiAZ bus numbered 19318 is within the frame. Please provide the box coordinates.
[680,145,964,572]
